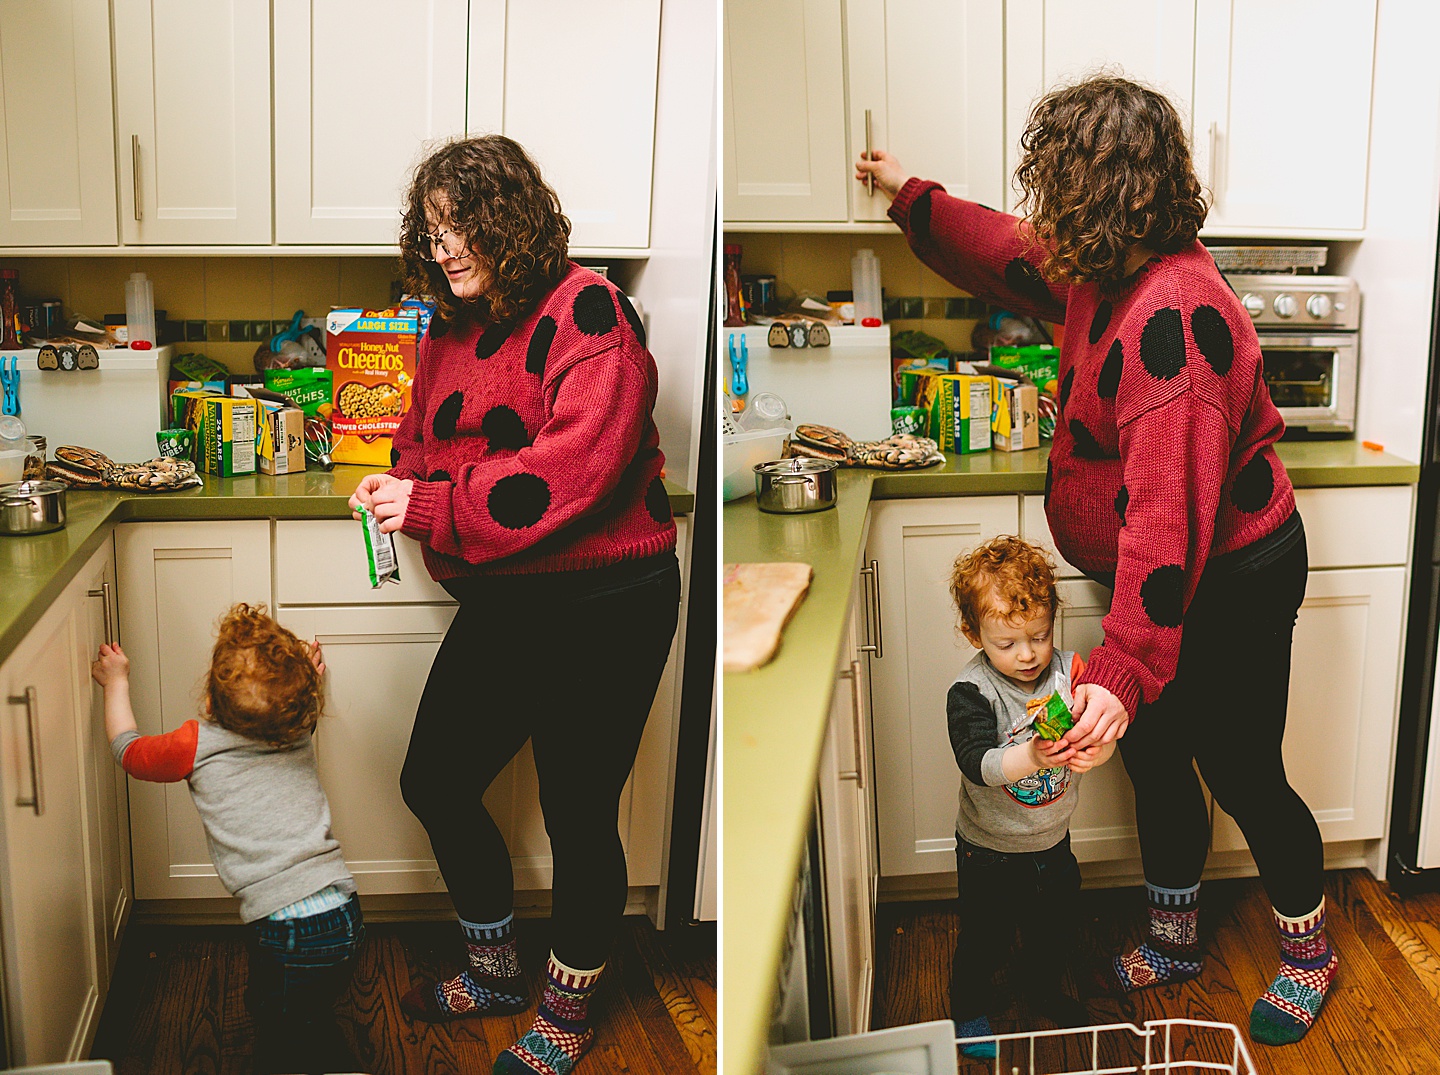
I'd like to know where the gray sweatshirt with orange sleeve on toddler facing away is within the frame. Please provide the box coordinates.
[109,720,356,922]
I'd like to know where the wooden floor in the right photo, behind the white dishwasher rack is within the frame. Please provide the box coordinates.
[874,871,1440,1075]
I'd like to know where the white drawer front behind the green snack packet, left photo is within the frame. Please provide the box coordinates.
[275,520,452,604]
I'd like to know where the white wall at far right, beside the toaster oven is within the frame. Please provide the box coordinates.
[1342,0,1440,461]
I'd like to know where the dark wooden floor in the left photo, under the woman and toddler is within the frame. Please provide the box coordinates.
[92,917,716,1075]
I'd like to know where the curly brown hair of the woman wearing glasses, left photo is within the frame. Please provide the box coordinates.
[400,134,570,332]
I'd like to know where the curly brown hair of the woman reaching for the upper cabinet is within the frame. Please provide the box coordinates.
[1015,75,1208,285]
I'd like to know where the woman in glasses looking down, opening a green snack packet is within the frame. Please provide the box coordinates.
[351,135,680,1075]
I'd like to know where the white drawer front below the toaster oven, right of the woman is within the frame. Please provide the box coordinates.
[1295,485,1411,568]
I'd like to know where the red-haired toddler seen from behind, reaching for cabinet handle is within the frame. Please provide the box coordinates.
[91,604,364,1071]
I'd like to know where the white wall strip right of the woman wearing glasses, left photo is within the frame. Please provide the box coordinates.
[632,0,719,489]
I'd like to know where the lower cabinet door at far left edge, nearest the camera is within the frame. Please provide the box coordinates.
[0,600,101,1063]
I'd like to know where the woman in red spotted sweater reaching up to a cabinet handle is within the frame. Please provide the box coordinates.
[855,76,1336,1045]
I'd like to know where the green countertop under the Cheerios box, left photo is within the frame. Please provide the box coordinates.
[0,465,696,673]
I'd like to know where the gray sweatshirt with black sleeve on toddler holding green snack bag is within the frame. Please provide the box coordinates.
[945,652,1083,852]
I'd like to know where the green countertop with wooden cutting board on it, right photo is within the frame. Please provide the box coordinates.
[721,440,1420,1075]
